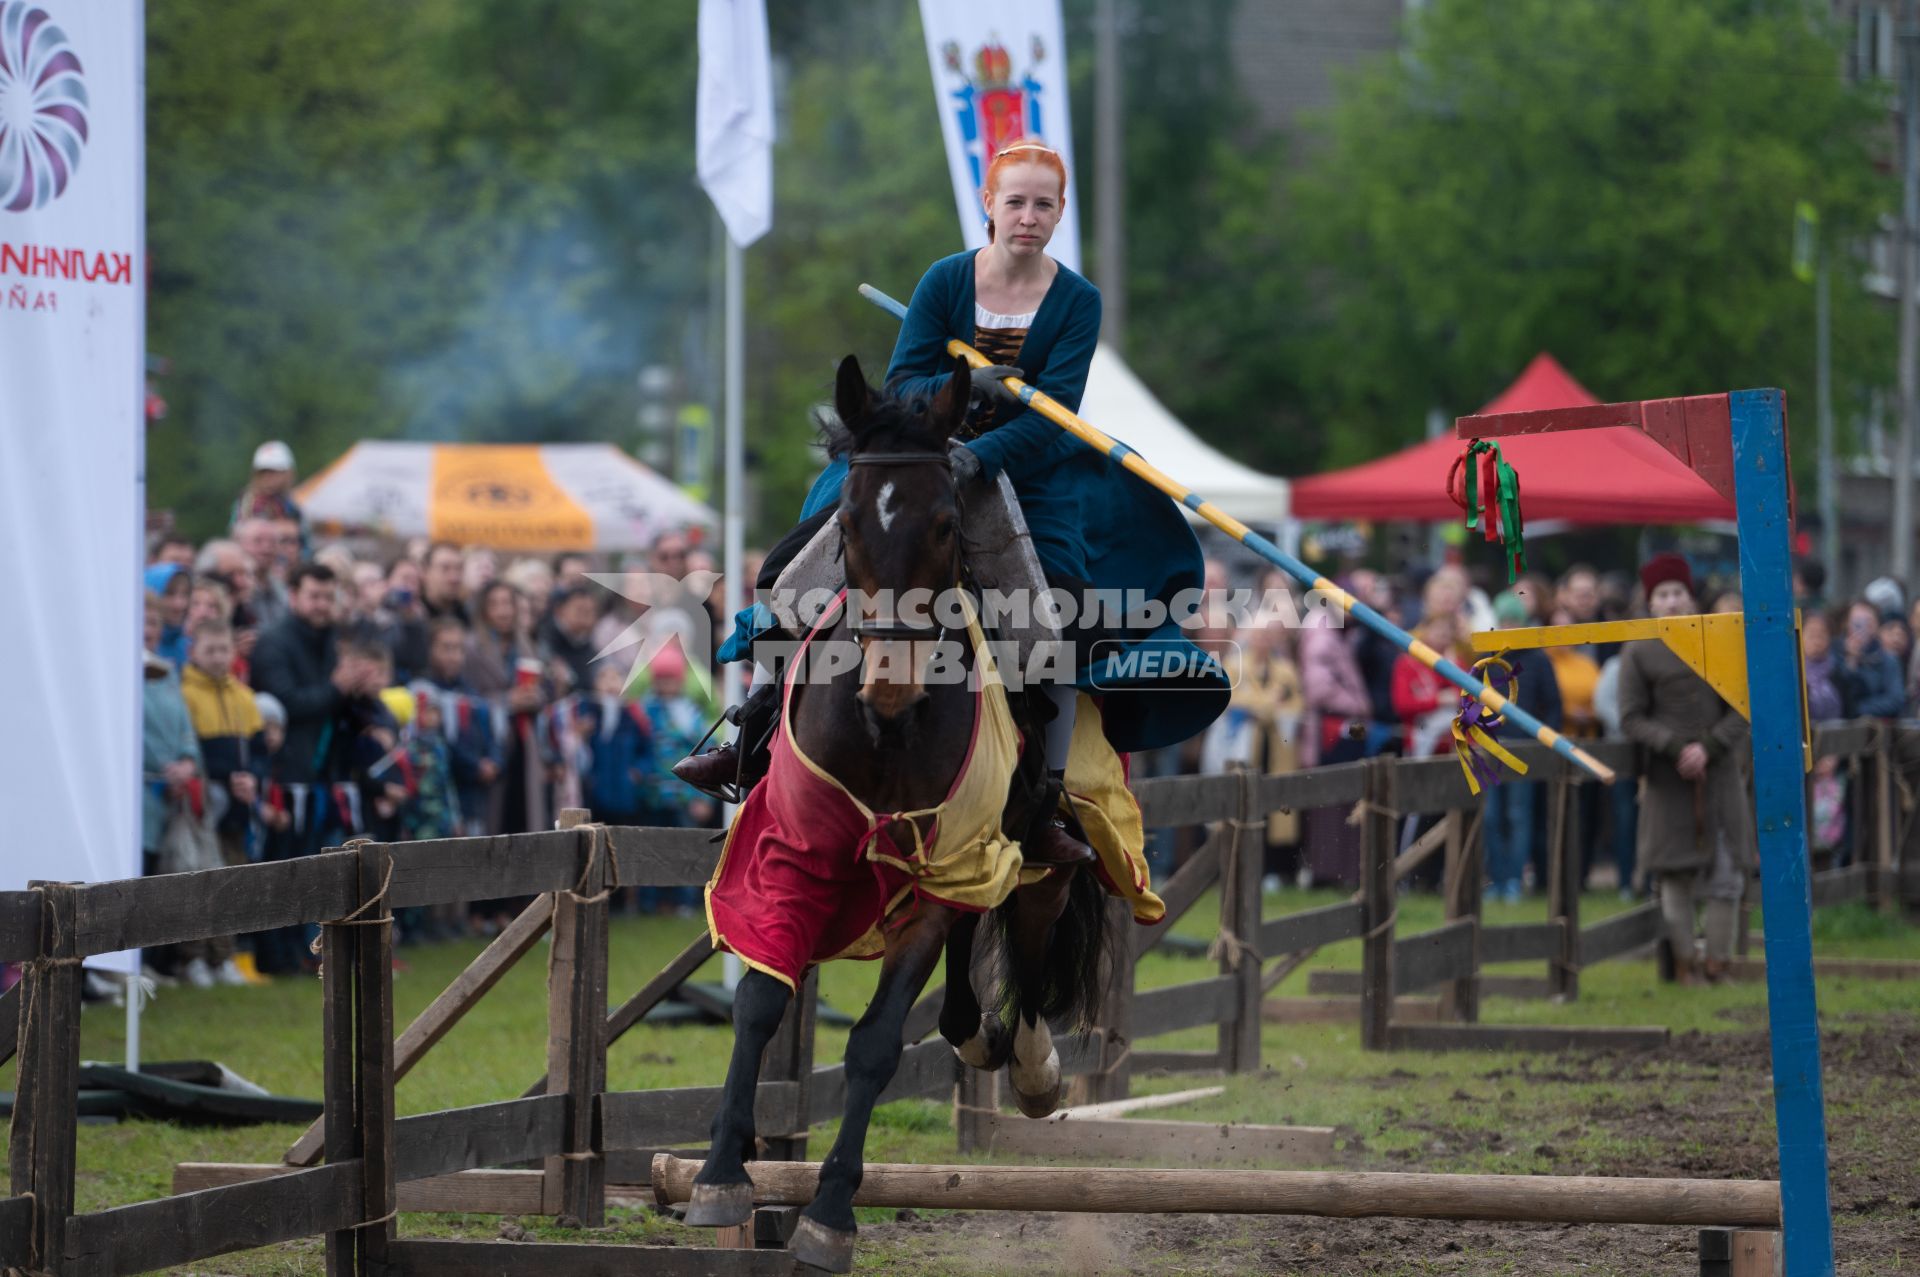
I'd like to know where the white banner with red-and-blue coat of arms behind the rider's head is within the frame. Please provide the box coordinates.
[920,0,1081,271]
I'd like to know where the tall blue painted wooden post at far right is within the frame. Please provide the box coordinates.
[1728,390,1834,1277]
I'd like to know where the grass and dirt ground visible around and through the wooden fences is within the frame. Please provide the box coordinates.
[0,891,1920,1275]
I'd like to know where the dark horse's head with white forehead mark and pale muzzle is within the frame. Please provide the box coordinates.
[833,355,972,728]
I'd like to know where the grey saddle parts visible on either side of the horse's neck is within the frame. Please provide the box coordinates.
[774,462,1060,682]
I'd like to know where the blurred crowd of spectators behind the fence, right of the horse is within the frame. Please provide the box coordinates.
[1167,555,1920,975]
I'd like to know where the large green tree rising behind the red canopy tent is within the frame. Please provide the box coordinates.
[1288,0,1891,468]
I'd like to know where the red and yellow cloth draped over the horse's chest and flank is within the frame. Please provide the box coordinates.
[707,591,1165,989]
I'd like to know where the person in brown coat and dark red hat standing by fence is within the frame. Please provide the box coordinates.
[1620,553,1757,983]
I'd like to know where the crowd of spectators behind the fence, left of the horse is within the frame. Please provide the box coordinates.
[142,444,718,985]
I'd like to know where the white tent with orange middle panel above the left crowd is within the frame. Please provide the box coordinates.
[294,440,718,551]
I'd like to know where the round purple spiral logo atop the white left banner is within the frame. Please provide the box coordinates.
[0,0,86,213]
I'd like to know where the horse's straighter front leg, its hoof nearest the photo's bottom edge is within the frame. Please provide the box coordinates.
[789,901,960,1273]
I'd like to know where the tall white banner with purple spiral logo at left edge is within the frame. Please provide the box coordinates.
[0,0,146,917]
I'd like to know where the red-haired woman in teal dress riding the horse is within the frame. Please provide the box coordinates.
[674,140,1227,864]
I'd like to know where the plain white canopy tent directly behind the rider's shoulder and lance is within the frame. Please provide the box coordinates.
[1079,346,1290,522]
